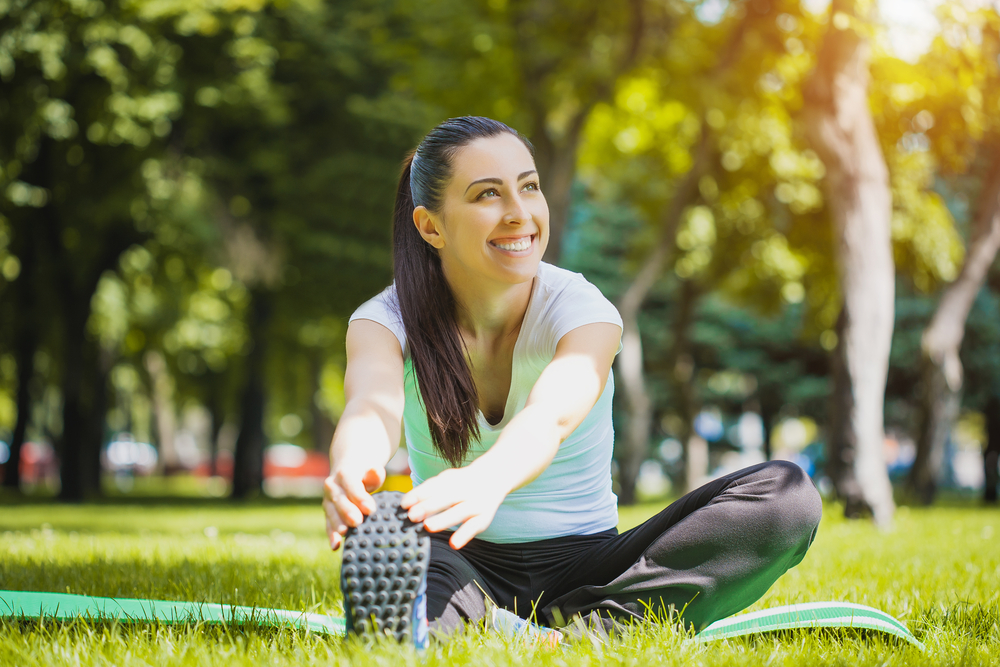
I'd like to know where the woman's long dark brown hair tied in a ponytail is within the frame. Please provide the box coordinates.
[392,116,533,467]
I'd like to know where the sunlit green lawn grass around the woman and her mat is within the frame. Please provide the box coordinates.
[0,500,1000,667]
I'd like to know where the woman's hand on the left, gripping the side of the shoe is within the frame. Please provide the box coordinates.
[323,465,385,550]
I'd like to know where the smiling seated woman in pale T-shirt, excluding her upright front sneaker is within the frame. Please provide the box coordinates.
[323,117,821,635]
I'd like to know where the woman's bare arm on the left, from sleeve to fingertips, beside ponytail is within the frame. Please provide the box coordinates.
[323,320,405,549]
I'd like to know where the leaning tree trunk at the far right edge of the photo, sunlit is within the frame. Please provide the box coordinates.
[909,157,1000,504]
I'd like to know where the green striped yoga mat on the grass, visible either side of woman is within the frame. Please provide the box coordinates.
[0,591,923,650]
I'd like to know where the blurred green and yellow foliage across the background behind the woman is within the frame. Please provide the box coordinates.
[0,0,1000,498]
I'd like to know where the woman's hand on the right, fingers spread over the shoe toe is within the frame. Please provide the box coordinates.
[400,465,510,549]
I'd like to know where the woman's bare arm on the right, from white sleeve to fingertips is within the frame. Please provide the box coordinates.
[402,323,622,549]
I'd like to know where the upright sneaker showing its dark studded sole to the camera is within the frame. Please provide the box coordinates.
[340,491,431,649]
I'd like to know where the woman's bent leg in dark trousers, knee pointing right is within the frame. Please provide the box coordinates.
[543,461,822,630]
